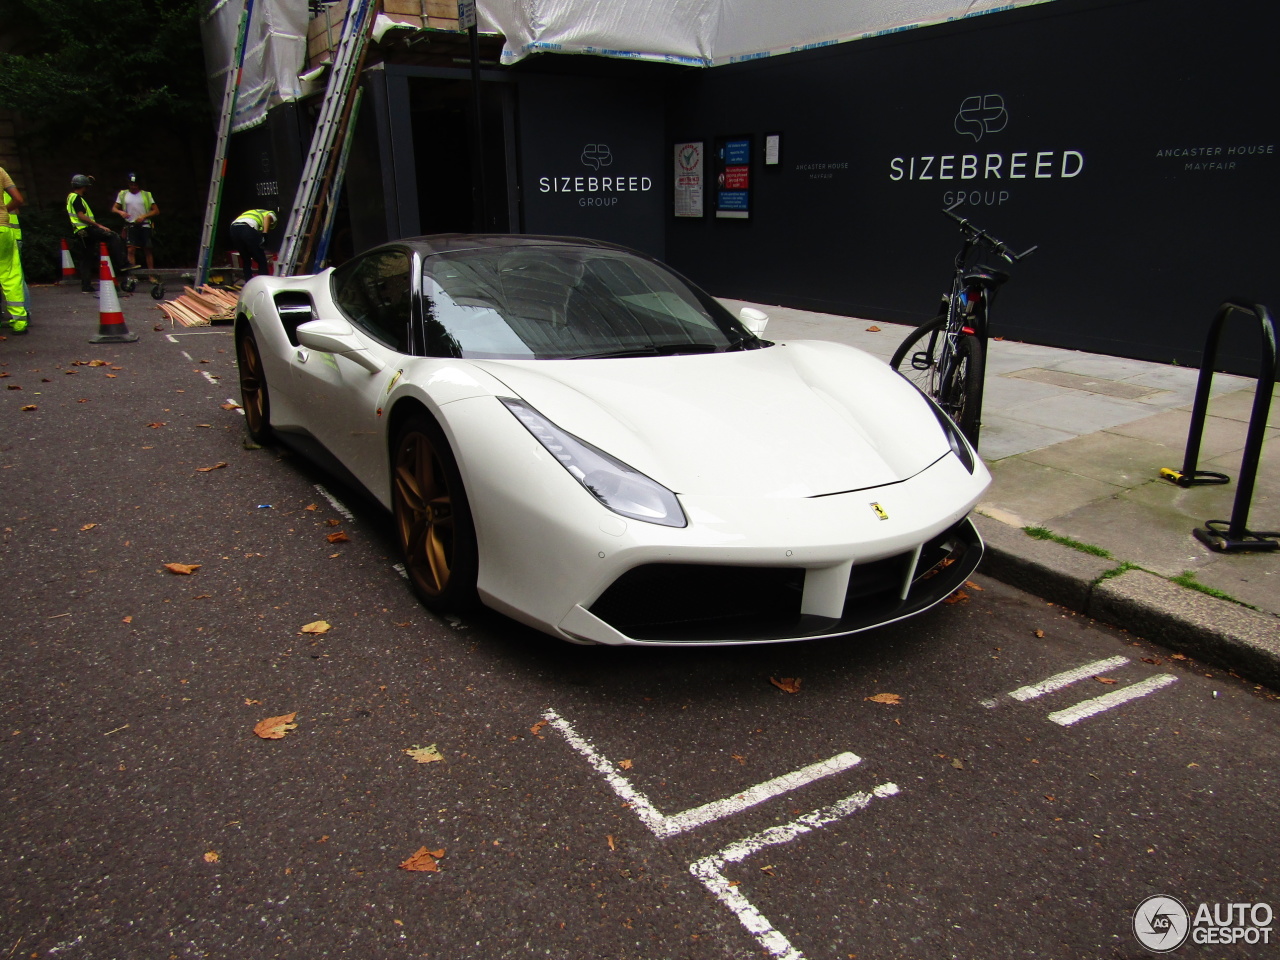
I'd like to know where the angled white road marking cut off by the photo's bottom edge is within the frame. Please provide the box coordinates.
[689,783,899,960]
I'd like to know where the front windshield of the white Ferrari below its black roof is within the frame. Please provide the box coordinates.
[422,244,760,360]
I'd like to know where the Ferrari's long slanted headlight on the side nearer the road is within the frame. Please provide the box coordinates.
[498,397,689,535]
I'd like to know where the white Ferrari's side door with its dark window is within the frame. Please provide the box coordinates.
[293,247,413,480]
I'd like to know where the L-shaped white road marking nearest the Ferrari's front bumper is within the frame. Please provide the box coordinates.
[543,710,861,837]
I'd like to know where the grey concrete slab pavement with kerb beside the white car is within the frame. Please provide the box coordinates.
[723,300,1280,689]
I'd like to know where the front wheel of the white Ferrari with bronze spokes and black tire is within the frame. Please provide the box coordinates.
[390,413,479,613]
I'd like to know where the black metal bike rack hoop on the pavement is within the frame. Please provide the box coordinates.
[1160,298,1280,553]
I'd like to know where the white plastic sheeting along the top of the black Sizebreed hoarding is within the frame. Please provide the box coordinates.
[476,0,1050,67]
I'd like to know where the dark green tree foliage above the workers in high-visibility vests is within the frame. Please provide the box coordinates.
[0,0,210,141]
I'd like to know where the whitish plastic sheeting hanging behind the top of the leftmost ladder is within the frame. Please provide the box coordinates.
[202,0,310,132]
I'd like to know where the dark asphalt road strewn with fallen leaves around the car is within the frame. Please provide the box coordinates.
[0,288,1280,960]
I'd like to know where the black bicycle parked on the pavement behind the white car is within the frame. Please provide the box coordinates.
[890,204,1037,449]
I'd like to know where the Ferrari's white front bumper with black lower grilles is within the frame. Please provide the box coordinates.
[447,401,989,645]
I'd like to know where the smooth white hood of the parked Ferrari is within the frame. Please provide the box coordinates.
[471,340,948,498]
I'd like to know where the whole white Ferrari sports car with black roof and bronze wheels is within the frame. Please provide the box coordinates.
[234,234,991,645]
